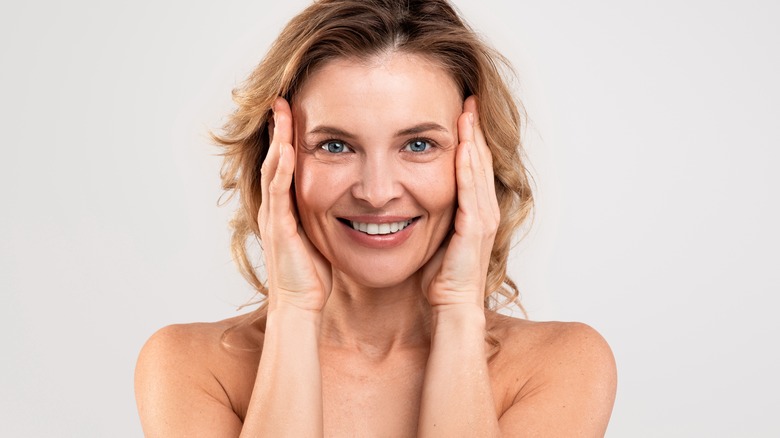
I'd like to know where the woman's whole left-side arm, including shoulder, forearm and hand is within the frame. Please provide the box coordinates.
[136,98,331,437]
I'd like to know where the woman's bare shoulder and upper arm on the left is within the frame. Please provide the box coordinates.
[135,318,258,436]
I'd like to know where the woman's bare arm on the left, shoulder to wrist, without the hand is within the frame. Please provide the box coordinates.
[135,307,322,438]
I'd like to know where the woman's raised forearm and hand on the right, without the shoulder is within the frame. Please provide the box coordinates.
[418,97,500,437]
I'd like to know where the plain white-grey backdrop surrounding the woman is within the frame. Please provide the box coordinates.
[0,0,780,437]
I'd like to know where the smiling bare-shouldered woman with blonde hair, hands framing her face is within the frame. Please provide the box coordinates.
[136,0,615,437]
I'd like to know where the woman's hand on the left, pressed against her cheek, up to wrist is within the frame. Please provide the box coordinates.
[257,97,332,312]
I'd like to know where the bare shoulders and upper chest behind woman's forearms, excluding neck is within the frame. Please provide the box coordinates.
[136,313,615,437]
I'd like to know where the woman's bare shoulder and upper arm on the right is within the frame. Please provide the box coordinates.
[488,314,617,436]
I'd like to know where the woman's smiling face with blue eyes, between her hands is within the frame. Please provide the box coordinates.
[292,53,463,287]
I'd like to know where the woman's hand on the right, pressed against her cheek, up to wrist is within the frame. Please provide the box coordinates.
[422,96,501,309]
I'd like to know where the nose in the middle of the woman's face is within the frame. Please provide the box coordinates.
[352,157,403,208]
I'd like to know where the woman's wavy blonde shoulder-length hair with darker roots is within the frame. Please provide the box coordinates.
[212,0,533,311]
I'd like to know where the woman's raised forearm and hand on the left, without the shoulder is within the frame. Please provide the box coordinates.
[241,98,331,437]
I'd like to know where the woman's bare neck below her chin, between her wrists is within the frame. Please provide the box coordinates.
[320,274,430,360]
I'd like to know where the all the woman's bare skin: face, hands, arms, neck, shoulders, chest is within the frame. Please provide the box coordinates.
[136,54,616,437]
